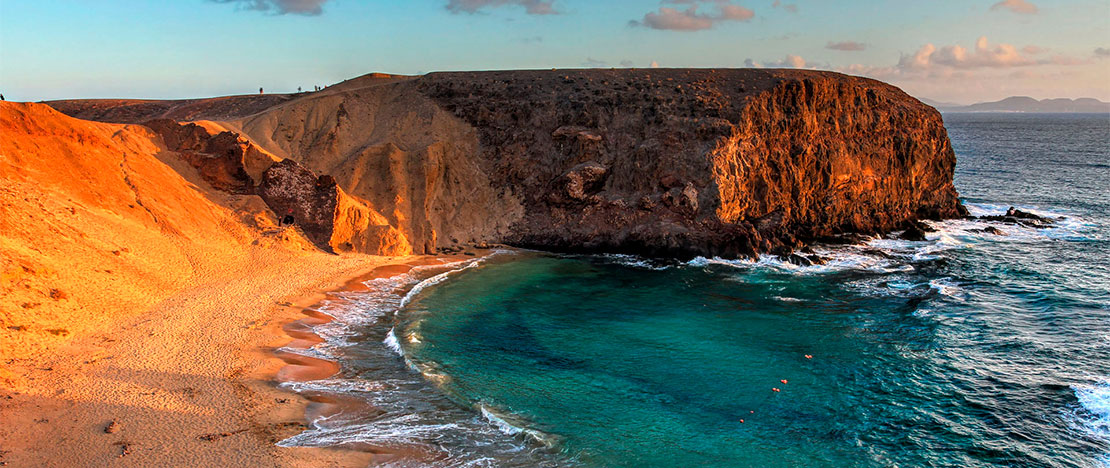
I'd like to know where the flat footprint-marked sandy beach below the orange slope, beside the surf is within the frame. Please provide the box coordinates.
[0,250,411,467]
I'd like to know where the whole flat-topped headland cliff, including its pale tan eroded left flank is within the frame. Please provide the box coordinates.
[45,69,963,257]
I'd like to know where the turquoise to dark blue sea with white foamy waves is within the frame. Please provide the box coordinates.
[280,113,1110,468]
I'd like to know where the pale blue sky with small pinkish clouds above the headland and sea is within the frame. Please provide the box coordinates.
[0,0,1110,103]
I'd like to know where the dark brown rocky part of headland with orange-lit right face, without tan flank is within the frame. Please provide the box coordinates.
[416,70,962,256]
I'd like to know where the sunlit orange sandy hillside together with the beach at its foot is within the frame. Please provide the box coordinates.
[0,102,399,467]
